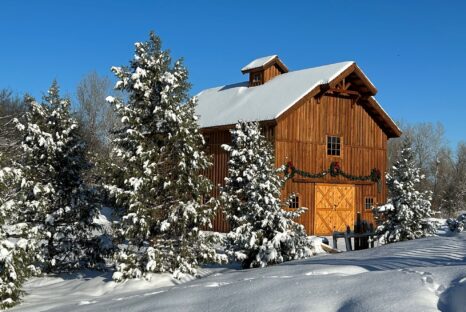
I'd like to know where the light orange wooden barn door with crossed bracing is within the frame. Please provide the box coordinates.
[314,184,356,235]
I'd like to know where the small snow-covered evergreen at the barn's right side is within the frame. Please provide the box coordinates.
[374,138,435,243]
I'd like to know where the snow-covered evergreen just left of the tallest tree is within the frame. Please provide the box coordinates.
[1,82,98,272]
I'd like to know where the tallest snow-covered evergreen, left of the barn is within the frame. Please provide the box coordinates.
[107,33,222,280]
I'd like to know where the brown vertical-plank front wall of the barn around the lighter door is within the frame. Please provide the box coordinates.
[275,96,387,233]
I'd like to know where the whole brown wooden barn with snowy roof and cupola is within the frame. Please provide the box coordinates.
[197,55,401,235]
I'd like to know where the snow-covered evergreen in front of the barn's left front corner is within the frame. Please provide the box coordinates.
[220,122,313,268]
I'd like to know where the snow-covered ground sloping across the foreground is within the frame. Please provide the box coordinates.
[13,233,466,312]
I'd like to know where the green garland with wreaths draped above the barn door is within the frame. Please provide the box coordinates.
[285,161,382,193]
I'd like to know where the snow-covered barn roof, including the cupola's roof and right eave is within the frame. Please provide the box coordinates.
[196,60,401,136]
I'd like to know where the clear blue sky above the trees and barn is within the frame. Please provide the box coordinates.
[0,0,466,146]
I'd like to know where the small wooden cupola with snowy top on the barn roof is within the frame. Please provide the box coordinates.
[241,55,288,87]
